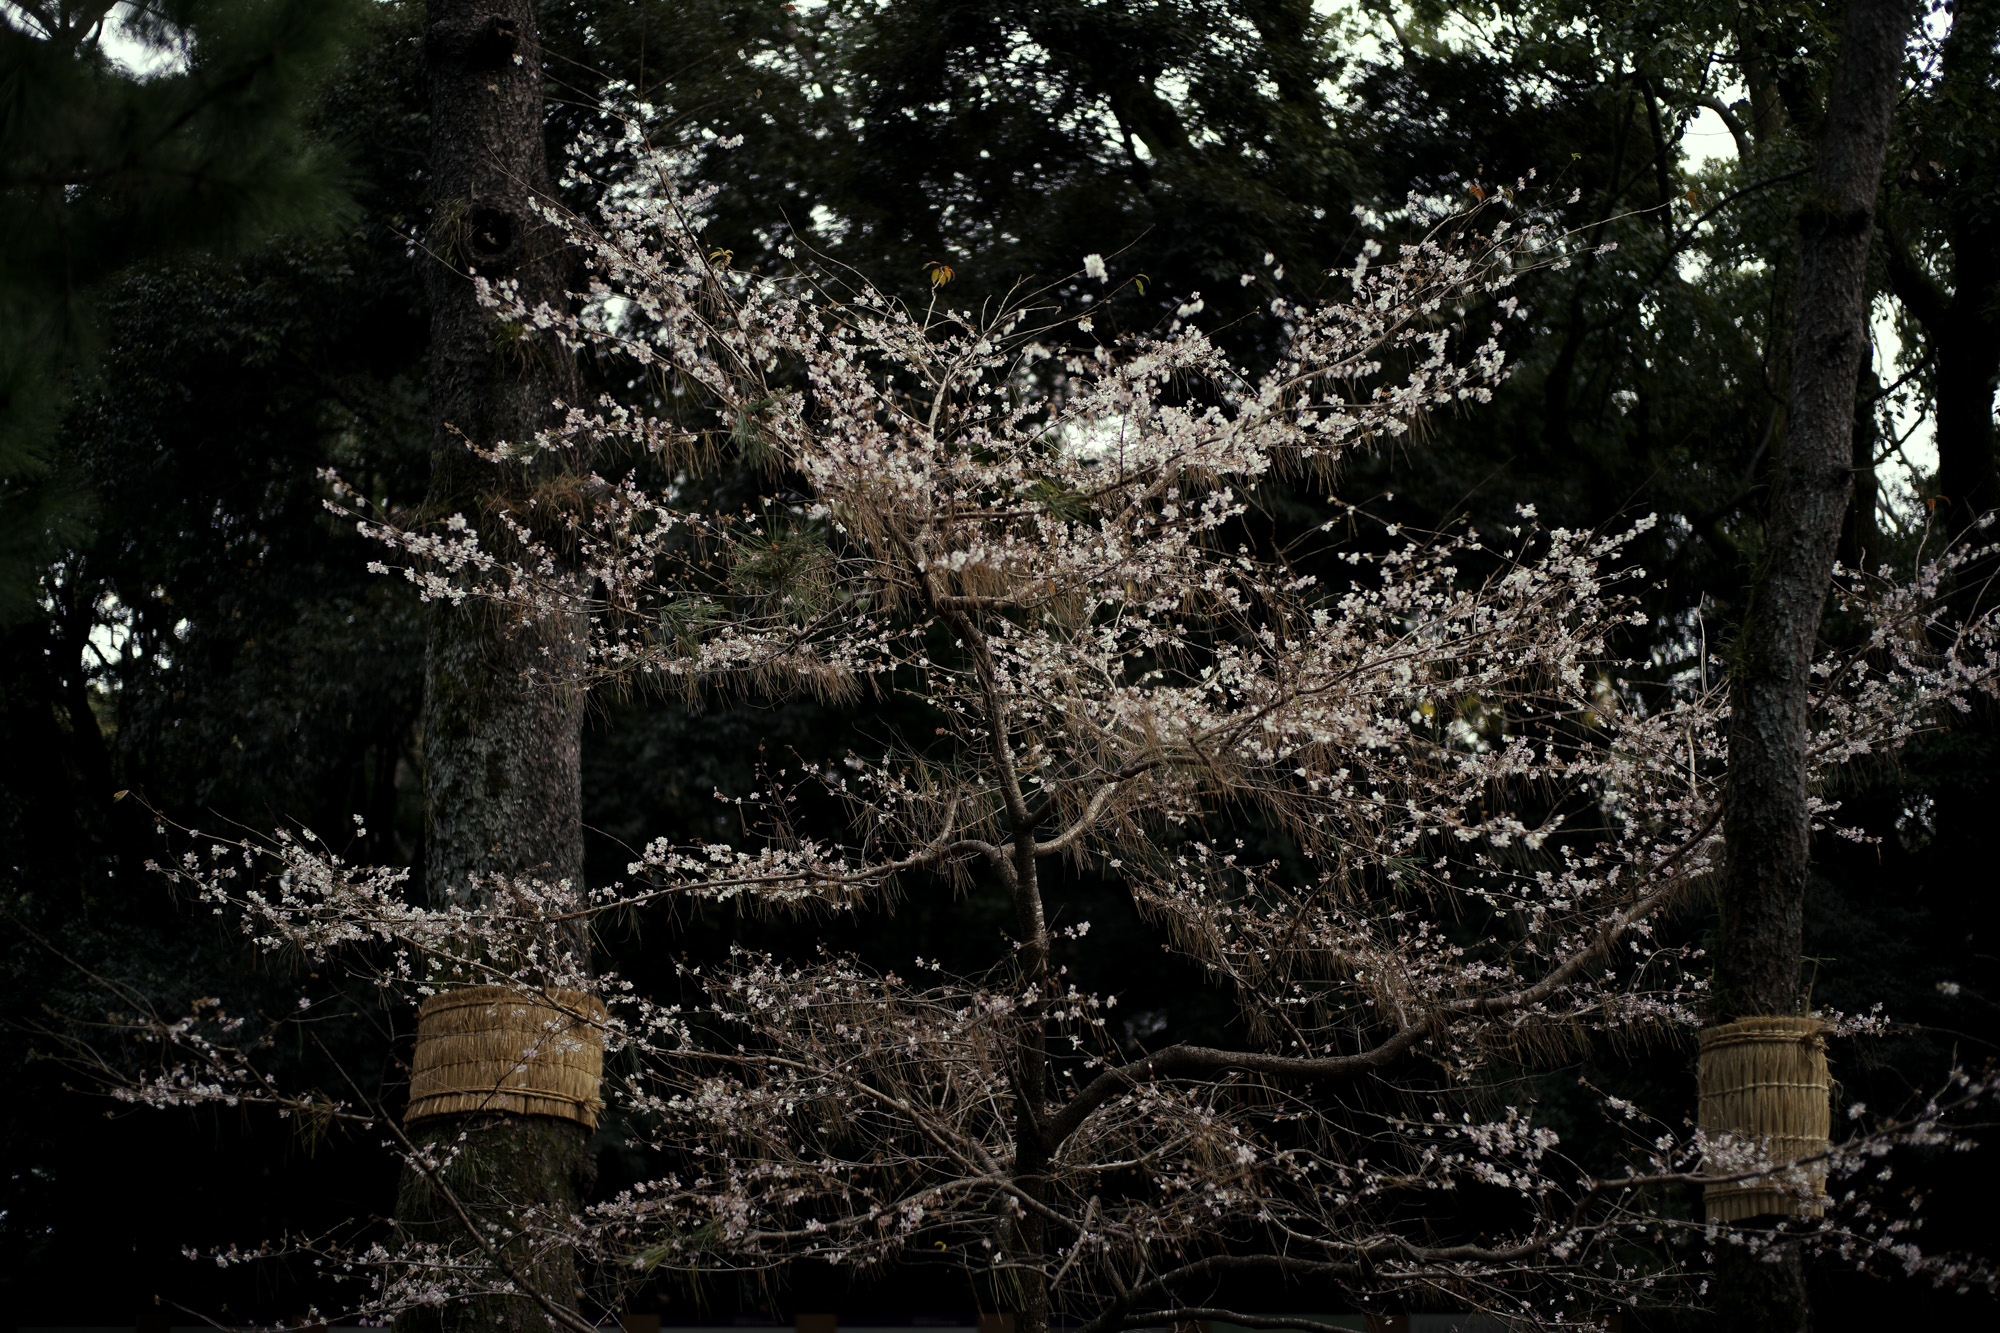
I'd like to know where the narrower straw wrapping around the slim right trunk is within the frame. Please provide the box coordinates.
[1700,1019,1832,1221]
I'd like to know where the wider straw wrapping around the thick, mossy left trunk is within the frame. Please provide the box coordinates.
[402,987,606,1129]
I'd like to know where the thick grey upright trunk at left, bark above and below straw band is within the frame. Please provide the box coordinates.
[396,0,592,1333]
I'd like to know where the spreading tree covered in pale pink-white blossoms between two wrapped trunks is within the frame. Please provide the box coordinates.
[58,144,2000,1333]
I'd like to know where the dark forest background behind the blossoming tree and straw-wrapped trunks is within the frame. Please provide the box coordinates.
[0,0,2000,1329]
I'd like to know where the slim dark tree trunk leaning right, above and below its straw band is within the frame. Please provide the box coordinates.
[1710,0,1912,1333]
